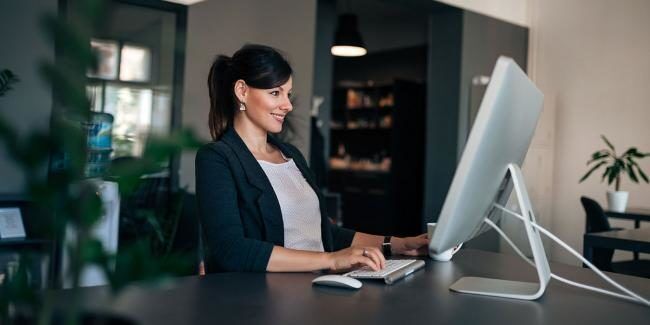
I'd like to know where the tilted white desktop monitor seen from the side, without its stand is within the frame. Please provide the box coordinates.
[429,56,543,253]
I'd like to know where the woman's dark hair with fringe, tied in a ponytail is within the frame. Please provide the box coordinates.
[208,44,292,141]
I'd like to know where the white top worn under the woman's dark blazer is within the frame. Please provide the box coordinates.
[258,157,324,252]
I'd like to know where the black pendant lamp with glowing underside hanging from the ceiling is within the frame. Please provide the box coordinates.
[331,14,368,57]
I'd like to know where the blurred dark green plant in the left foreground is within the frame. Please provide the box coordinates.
[0,0,200,324]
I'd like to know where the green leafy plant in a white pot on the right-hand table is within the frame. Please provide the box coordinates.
[580,135,650,212]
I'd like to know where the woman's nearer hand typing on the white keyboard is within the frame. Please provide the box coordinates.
[328,247,386,271]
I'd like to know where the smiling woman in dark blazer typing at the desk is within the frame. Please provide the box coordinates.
[196,45,428,272]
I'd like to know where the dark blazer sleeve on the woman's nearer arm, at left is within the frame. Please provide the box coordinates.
[195,144,273,272]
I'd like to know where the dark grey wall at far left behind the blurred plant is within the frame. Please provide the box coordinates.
[0,0,57,196]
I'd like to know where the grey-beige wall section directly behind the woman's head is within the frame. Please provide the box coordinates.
[180,0,316,191]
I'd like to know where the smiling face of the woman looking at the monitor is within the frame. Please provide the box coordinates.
[235,77,293,133]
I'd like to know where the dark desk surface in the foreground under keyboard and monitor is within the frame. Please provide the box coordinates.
[58,249,650,325]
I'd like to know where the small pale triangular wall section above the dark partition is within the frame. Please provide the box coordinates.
[434,0,531,27]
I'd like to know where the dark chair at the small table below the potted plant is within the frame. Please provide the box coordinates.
[580,196,650,278]
